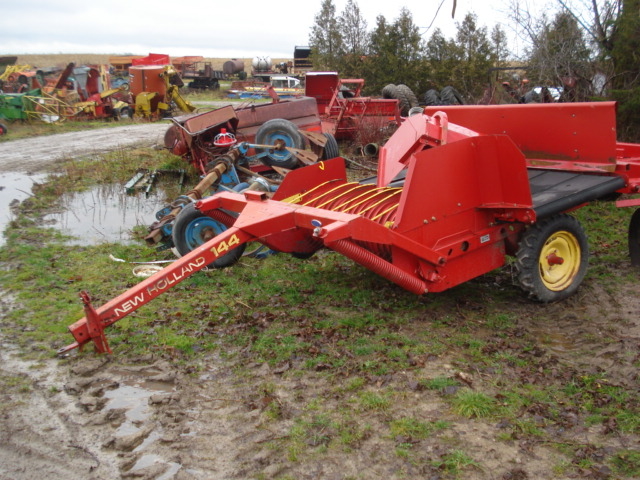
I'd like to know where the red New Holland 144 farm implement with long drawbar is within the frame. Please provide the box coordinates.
[60,102,640,353]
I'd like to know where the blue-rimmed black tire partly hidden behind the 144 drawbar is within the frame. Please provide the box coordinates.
[171,203,246,268]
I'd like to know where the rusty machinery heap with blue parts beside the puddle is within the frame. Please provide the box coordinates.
[145,98,339,254]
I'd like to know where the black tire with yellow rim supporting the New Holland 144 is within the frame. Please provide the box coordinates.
[516,214,589,303]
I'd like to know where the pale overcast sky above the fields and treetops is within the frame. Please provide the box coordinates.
[0,0,528,58]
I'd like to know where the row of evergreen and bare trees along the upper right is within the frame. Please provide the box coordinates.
[309,0,640,141]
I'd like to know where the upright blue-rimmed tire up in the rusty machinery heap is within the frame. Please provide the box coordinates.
[256,118,305,169]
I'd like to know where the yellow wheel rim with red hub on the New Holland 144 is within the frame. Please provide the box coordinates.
[538,230,581,292]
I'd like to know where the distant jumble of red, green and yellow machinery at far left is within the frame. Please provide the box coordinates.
[0,54,195,130]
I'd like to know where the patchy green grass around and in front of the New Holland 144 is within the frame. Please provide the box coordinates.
[0,133,640,479]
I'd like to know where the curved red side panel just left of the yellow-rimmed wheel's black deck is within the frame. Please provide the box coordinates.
[396,135,531,237]
